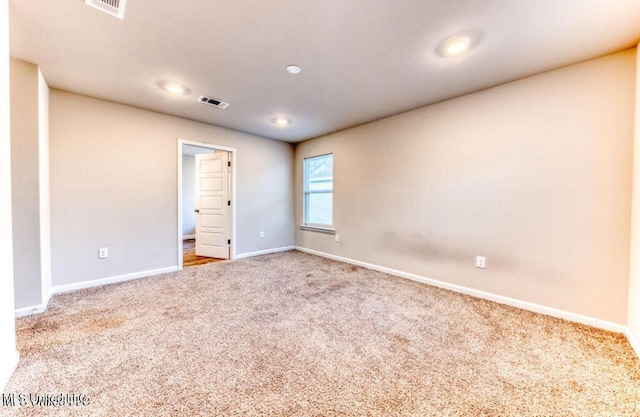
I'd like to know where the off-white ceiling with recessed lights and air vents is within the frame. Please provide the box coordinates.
[10,0,640,142]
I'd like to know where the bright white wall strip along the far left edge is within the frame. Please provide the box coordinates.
[0,0,18,391]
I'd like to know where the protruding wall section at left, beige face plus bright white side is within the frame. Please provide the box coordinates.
[11,59,51,311]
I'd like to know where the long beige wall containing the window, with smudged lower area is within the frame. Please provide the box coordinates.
[295,50,636,324]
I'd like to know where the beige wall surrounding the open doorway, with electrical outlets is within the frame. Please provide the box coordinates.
[50,89,293,286]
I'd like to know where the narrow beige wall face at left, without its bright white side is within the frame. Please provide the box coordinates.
[11,59,42,308]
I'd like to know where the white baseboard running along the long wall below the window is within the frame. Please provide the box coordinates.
[296,246,624,334]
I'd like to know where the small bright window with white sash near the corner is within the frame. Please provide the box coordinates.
[304,154,333,227]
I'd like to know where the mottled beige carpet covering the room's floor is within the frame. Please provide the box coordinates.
[0,252,640,417]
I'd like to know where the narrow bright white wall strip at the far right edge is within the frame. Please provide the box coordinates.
[628,44,640,356]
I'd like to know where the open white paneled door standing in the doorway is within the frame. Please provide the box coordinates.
[196,152,230,259]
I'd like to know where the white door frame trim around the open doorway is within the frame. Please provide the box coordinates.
[176,139,238,271]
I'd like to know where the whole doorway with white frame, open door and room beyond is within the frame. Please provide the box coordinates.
[177,139,236,270]
